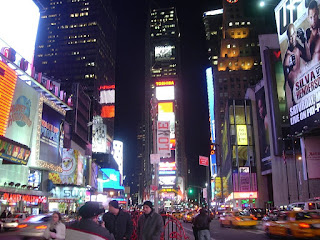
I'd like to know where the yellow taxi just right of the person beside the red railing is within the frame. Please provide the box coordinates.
[219,212,257,227]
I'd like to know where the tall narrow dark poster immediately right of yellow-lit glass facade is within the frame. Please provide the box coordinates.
[256,87,271,174]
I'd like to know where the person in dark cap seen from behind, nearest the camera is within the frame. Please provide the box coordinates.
[66,202,114,240]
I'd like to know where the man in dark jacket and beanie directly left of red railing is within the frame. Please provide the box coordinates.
[138,201,163,240]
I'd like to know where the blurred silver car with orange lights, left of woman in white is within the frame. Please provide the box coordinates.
[17,213,52,239]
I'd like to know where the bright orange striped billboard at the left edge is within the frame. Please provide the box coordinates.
[0,61,17,136]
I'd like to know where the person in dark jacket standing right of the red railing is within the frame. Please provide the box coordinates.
[193,208,211,240]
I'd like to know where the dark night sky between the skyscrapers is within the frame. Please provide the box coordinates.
[112,0,276,186]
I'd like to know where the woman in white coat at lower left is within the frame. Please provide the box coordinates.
[44,212,66,240]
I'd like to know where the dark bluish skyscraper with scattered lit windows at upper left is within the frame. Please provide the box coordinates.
[34,0,116,99]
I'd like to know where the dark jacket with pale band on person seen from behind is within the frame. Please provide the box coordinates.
[66,219,114,240]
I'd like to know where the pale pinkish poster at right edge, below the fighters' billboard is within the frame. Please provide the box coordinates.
[305,137,320,179]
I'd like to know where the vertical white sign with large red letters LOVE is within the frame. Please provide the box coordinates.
[157,121,171,158]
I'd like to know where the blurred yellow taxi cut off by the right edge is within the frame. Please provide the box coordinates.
[265,211,320,238]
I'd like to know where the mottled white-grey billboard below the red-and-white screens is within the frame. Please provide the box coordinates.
[92,116,107,153]
